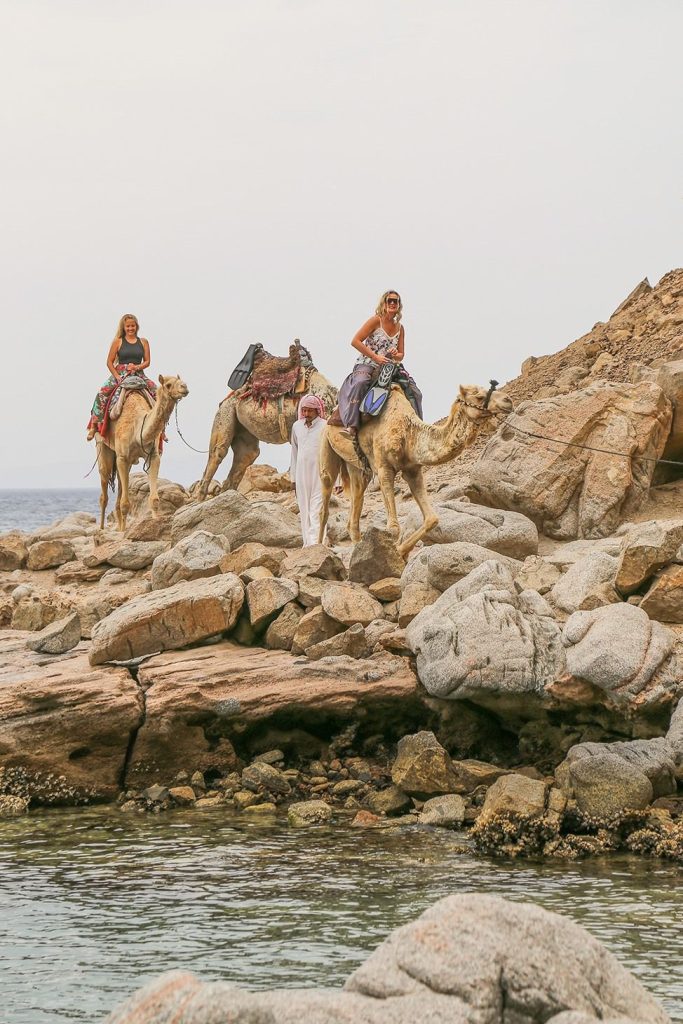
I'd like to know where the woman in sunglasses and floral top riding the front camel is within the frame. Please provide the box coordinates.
[339,290,422,436]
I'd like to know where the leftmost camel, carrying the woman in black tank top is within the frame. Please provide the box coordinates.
[97,376,189,530]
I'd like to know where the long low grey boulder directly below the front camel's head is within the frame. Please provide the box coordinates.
[403,500,539,559]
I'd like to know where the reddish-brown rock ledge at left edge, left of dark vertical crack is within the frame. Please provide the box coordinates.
[0,631,144,804]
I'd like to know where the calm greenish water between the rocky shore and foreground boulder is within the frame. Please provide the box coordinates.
[0,808,683,1024]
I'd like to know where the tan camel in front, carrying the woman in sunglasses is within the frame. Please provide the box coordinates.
[318,384,513,558]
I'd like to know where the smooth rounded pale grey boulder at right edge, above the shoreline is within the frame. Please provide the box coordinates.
[562,604,681,708]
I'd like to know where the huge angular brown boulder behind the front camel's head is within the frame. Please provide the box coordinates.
[471,381,672,539]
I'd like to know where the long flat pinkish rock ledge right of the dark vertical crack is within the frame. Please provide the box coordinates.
[128,641,416,785]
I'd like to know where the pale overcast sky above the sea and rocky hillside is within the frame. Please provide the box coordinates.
[0,0,683,486]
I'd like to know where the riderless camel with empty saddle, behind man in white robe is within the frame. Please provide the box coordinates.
[197,346,337,502]
